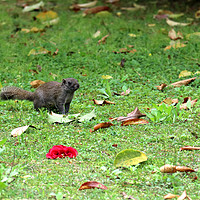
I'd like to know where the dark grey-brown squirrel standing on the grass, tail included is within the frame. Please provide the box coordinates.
[0,78,79,114]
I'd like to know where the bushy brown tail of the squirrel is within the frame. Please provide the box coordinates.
[0,86,34,101]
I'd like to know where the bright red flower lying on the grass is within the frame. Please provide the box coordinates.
[46,145,78,159]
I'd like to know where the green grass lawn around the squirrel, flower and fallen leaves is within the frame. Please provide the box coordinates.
[0,1,200,200]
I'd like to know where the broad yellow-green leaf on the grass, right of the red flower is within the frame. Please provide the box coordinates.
[114,149,147,167]
